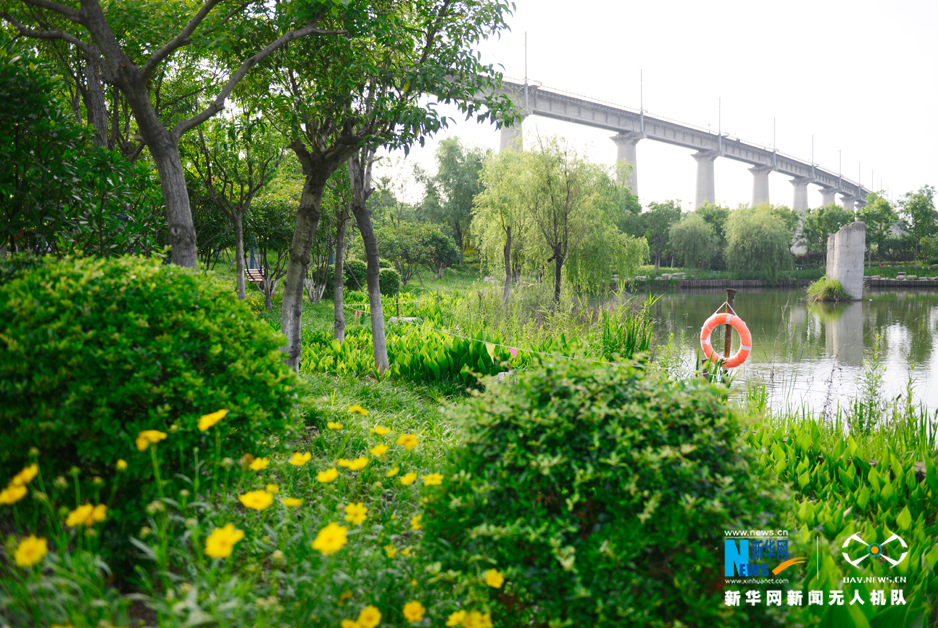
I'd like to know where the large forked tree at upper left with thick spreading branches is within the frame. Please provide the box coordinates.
[0,0,346,268]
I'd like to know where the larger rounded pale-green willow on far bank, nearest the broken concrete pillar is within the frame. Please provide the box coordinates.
[726,207,791,281]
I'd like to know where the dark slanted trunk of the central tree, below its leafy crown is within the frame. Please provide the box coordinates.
[280,169,329,372]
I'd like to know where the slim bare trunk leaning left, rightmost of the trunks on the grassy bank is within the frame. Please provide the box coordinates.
[348,148,390,375]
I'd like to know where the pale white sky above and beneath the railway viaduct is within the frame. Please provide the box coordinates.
[378,0,938,210]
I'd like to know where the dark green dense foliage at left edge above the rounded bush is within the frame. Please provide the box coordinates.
[0,45,163,256]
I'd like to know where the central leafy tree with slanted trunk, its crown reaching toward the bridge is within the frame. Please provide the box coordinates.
[252,0,512,369]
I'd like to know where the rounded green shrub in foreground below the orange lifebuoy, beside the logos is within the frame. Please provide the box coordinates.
[423,361,783,627]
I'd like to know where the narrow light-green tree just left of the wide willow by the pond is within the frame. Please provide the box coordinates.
[423,137,488,264]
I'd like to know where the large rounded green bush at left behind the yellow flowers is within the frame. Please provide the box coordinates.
[0,257,294,525]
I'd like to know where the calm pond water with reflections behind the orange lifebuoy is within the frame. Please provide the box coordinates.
[653,289,938,414]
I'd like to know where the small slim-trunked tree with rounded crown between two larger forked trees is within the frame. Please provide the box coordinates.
[183,112,282,301]
